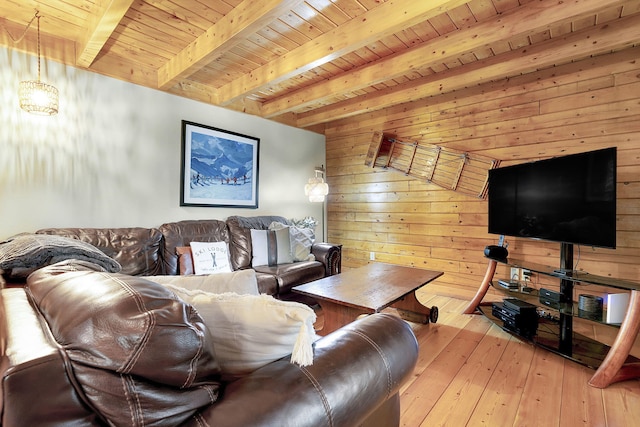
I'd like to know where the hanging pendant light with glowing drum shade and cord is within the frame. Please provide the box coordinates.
[18,10,58,116]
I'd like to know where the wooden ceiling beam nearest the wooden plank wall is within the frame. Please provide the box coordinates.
[296,10,640,127]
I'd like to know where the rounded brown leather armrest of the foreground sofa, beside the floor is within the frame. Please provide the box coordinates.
[187,314,418,427]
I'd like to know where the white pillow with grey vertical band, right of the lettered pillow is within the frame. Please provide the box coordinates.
[251,228,293,267]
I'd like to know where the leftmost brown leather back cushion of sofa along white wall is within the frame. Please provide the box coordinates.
[36,227,162,276]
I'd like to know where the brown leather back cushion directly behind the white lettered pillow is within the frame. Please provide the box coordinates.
[159,219,230,276]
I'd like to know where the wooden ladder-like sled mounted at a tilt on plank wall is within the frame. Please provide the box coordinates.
[364,132,500,199]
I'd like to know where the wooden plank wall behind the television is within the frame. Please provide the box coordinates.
[325,48,640,298]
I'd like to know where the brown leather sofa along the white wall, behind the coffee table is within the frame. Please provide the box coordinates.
[36,216,342,300]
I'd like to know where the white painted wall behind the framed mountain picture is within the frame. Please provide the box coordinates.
[0,48,325,238]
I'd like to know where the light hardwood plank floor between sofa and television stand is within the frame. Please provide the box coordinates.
[401,292,640,427]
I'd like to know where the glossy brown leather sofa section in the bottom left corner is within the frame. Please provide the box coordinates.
[0,287,104,427]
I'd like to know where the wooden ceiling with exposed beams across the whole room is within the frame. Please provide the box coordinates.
[0,0,640,132]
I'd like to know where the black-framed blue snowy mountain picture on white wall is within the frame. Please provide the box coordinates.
[180,120,260,209]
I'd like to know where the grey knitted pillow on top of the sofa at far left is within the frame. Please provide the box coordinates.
[0,233,121,278]
